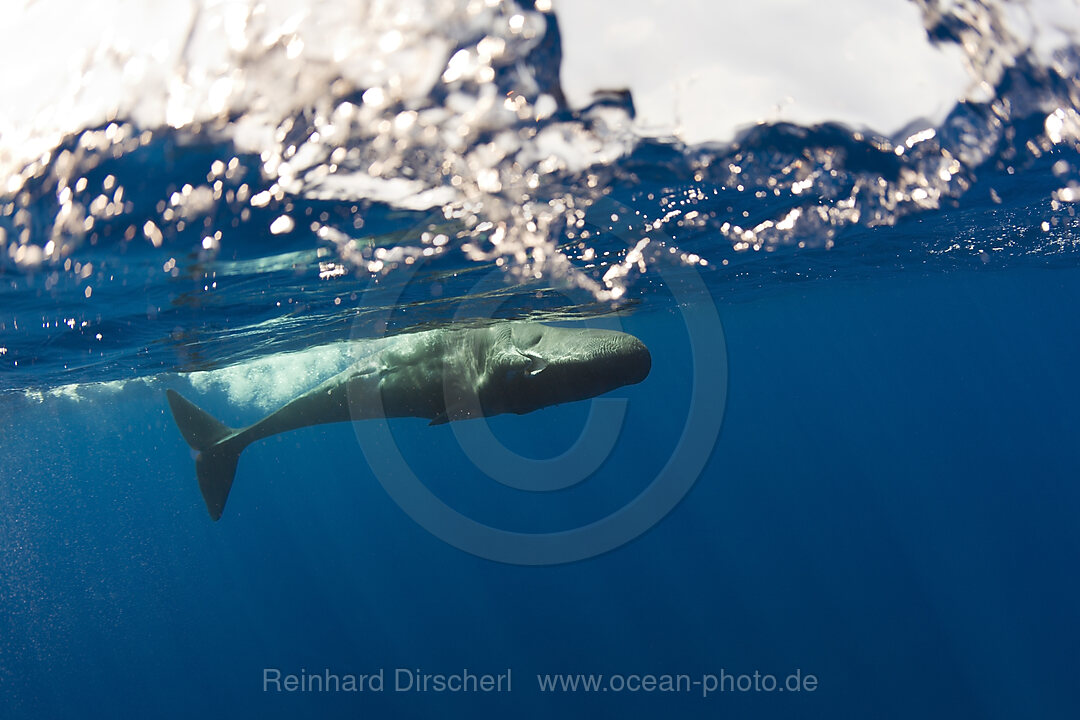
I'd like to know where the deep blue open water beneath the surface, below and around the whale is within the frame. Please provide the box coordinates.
[0,264,1080,718]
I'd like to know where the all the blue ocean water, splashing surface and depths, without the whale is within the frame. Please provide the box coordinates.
[0,3,1080,719]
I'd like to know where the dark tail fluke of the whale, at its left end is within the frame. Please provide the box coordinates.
[165,390,246,520]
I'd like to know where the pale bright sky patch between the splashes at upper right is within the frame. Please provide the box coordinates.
[555,0,972,144]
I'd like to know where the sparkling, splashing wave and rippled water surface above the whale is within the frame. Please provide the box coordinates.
[0,0,1080,395]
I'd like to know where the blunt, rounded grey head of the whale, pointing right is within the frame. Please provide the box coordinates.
[484,323,652,415]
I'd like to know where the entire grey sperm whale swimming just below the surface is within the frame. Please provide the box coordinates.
[166,322,652,520]
